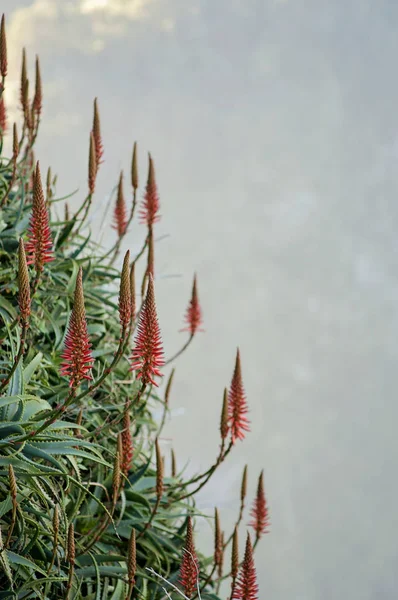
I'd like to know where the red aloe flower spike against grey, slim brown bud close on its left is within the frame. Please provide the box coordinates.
[228,348,250,444]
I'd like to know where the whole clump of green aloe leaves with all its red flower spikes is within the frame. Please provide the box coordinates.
[0,17,268,600]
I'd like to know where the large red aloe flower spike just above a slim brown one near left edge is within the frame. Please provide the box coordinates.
[26,162,54,273]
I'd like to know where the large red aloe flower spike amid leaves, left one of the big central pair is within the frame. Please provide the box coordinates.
[61,267,94,388]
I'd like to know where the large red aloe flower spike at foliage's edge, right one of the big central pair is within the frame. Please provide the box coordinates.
[130,275,164,386]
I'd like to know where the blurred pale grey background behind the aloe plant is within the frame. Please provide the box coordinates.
[1,0,398,600]
